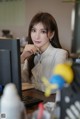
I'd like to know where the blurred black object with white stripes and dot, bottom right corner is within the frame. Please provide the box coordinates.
[60,63,80,119]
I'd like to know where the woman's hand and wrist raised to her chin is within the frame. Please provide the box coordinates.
[21,44,38,63]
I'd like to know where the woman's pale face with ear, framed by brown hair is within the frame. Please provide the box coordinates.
[31,23,51,52]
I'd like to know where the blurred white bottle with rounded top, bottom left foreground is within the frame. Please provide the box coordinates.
[0,83,27,119]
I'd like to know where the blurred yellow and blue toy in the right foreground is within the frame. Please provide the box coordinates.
[42,63,74,96]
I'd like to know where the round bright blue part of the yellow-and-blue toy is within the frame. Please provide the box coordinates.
[49,75,65,89]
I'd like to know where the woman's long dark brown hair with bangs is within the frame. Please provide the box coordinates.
[28,12,61,78]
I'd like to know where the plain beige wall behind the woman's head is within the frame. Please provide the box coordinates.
[0,0,74,51]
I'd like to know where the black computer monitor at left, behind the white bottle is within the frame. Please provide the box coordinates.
[0,39,21,96]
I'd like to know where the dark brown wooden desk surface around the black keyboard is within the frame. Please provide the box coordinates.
[23,88,55,113]
